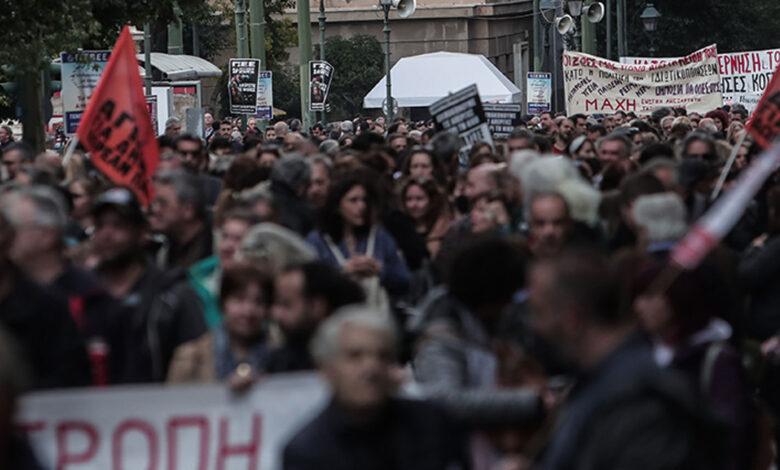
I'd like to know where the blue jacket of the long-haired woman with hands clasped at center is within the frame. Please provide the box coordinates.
[306,227,411,296]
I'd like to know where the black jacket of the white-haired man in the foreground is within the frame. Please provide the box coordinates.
[283,399,468,470]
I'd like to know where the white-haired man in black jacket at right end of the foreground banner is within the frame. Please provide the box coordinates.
[283,307,469,470]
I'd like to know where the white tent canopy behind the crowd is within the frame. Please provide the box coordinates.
[363,52,522,108]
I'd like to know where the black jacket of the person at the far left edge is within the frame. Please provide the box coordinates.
[0,268,90,389]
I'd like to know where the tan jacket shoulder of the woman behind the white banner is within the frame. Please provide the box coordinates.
[166,333,217,384]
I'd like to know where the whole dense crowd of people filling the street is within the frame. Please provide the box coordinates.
[0,98,780,470]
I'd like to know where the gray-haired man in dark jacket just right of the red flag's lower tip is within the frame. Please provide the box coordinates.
[149,170,214,269]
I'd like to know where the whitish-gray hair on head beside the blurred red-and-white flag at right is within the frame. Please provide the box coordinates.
[631,192,688,243]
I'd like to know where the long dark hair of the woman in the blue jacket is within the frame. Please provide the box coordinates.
[320,173,377,243]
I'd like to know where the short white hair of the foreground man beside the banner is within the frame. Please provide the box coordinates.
[310,305,397,363]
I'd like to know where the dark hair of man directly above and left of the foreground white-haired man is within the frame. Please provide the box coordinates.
[292,261,366,313]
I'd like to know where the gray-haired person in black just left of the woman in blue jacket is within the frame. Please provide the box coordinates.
[271,153,316,237]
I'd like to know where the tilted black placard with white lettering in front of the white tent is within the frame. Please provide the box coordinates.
[428,84,493,166]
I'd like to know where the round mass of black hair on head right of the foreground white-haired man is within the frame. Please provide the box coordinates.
[446,235,525,311]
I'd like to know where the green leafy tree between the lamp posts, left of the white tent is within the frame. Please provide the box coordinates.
[312,35,384,120]
